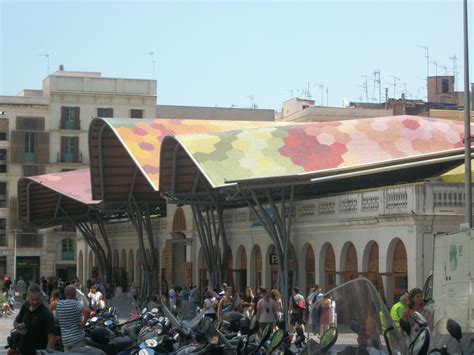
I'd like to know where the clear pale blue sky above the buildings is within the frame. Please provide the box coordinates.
[0,0,474,111]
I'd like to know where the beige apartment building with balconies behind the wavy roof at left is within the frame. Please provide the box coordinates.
[0,66,156,280]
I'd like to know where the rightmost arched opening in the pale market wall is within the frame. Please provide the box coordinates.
[387,238,408,304]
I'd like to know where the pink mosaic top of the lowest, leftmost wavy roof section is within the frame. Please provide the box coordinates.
[23,169,100,205]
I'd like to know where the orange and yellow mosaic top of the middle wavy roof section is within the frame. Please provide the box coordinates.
[100,118,295,191]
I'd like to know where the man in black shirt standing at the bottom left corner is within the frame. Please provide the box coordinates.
[13,284,56,355]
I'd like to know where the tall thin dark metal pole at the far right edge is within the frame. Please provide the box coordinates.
[463,0,472,228]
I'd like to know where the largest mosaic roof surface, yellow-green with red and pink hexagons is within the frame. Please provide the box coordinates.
[168,116,464,187]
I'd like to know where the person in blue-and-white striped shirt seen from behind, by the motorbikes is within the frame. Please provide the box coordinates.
[56,285,90,352]
